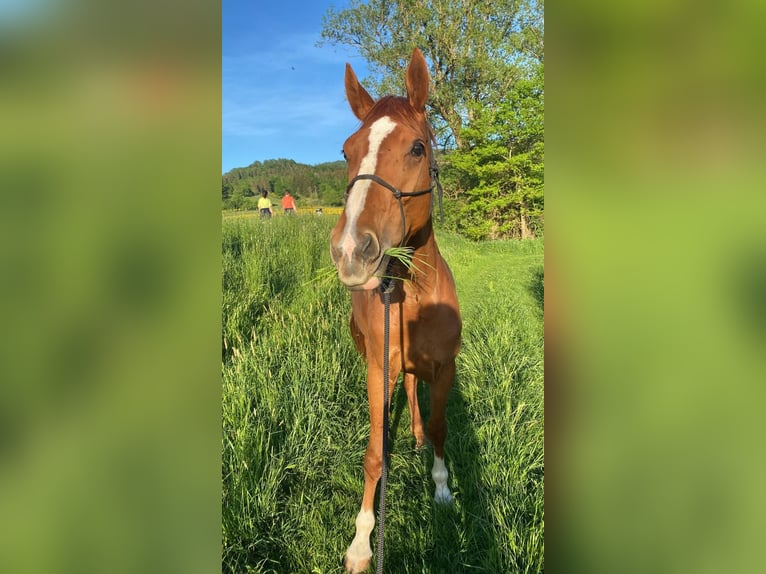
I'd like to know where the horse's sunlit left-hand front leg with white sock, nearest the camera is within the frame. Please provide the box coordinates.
[343,364,399,573]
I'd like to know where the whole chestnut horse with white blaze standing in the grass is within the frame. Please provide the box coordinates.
[330,48,461,572]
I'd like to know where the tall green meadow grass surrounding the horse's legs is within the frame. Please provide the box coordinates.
[222,217,544,574]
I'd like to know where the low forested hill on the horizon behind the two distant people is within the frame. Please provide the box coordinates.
[221,159,348,209]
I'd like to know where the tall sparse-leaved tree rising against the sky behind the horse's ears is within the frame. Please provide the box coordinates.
[319,0,543,148]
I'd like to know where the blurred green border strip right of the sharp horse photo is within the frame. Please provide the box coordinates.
[545,2,766,573]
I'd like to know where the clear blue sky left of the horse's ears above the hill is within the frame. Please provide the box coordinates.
[221,0,367,173]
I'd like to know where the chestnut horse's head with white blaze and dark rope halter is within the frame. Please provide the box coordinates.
[330,48,431,290]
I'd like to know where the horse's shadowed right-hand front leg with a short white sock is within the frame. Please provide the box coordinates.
[428,361,455,504]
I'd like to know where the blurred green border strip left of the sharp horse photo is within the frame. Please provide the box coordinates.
[0,1,221,573]
